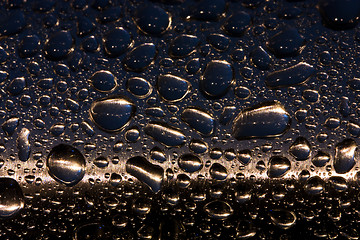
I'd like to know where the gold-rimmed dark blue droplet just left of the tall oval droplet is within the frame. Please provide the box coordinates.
[156,74,191,102]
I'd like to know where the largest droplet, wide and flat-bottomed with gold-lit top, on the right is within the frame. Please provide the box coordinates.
[232,102,291,140]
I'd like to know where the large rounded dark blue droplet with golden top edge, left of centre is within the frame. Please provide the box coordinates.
[90,98,135,132]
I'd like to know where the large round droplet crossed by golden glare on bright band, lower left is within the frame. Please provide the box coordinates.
[46,144,86,186]
